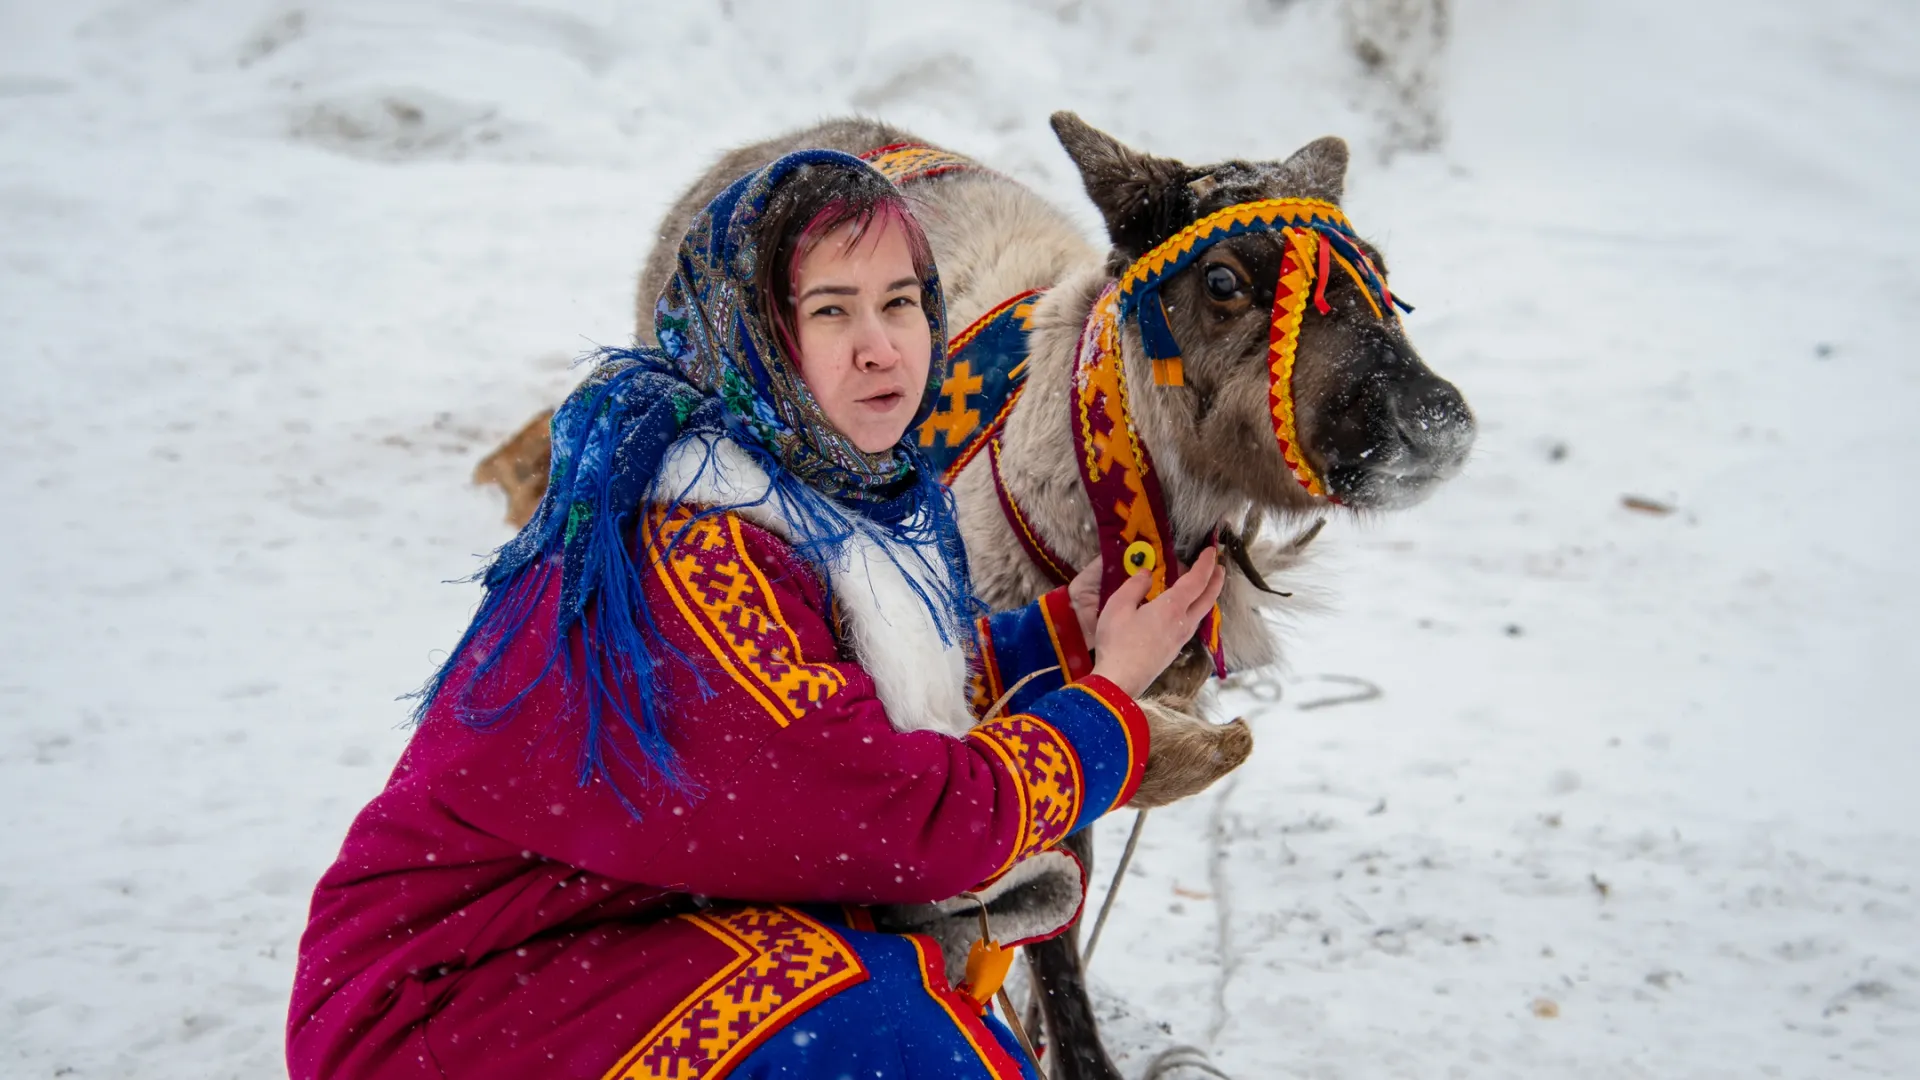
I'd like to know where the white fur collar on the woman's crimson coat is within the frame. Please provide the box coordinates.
[660,438,973,736]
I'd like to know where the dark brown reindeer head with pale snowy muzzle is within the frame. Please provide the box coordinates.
[1052,111,1475,509]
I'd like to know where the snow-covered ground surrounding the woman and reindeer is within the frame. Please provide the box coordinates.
[0,0,1920,1078]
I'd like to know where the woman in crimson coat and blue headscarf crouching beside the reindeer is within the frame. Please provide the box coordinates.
[288,152,1221,1080]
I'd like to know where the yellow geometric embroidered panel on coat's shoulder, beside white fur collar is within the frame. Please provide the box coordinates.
[645,507,847,726]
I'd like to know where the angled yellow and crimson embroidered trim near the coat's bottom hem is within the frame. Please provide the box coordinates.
[603,907,868,1080]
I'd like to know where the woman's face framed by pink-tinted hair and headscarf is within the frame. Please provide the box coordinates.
[793,219,933,454]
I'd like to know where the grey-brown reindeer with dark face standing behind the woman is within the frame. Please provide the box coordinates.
[476,111,1475,1078]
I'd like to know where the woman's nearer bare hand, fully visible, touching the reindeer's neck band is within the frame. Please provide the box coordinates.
[1092,548,1227,698]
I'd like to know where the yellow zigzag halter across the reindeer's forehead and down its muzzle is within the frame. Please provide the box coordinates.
[1116,198,1413,498]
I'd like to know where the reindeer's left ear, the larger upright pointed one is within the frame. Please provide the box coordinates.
[1052,111,1200,258]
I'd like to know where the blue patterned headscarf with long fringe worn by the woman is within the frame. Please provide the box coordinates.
[417,150,975,813]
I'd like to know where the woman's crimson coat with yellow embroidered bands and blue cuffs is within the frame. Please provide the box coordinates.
[288,515,1146,1080]
